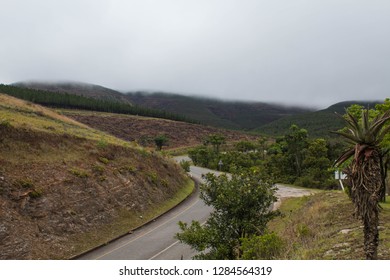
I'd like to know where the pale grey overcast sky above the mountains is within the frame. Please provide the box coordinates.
[0,0,390,107]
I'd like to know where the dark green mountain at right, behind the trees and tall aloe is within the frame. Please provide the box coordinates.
[255,101,381,137]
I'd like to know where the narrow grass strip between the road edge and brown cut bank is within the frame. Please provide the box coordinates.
[68,178,195,258]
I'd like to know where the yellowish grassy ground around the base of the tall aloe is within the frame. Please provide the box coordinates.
[269,191,390,260]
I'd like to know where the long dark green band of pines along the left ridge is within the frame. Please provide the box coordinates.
[0,84,199,123]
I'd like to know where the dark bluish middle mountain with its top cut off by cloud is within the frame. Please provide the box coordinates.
[127,92,311,130]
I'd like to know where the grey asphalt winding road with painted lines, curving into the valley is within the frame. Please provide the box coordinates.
[76,157,310,260]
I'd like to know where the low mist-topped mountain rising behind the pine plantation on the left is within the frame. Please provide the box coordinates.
[12,82,131,103]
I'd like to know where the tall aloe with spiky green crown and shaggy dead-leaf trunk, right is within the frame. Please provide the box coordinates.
[335,110,390,259]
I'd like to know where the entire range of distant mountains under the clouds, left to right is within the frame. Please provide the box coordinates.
[14,82,380,137]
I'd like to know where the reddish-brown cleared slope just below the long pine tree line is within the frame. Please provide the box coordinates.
[65,111,256,149]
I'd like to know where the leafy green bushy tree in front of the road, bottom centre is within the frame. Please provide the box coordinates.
[176,169,277,259]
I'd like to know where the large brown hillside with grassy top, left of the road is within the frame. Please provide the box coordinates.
[0,94,193,259]
